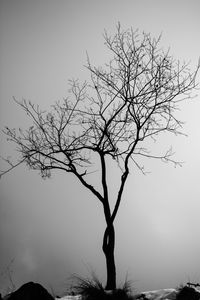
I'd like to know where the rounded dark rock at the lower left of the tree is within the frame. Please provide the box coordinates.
[9,282,54,300]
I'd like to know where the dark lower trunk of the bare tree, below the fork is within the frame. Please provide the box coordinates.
[103,224,116,290]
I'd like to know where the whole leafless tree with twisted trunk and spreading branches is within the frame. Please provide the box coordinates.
[0,24,200,289]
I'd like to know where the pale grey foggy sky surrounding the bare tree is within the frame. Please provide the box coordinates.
[0,0,200,294]
